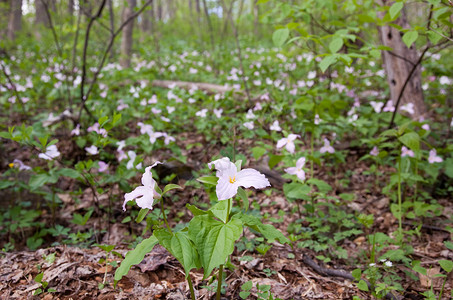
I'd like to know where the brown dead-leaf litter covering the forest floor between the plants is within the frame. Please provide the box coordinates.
[0,125,453,299]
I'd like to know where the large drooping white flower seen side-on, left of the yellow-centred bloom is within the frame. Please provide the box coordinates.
[123,161,161,211]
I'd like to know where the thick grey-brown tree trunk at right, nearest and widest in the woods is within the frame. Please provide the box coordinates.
[377,0,426,120]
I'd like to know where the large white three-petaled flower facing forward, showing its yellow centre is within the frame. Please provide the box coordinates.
[208,157,271,201]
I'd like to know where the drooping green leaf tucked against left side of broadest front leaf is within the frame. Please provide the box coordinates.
[154,229,200,279]
